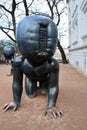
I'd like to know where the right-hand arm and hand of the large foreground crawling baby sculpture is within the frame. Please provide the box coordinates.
[45,60,63,118]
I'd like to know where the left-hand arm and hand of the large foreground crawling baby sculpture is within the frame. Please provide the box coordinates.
[3,57,23,111]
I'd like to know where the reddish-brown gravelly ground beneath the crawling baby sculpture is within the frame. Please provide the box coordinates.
[0,64,87,130]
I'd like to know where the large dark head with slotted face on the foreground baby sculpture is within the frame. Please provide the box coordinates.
[16,15,57,63]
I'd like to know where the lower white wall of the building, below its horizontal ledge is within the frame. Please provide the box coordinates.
[69,49,87,76]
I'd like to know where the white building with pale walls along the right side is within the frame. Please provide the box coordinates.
[68,0,87,76]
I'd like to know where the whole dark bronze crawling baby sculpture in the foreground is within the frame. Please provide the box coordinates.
[4,15,62,117]
